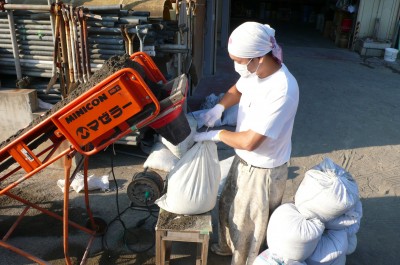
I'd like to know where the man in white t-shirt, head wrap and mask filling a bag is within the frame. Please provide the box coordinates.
[194,22,299,265]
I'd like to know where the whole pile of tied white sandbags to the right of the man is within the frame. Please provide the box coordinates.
[254,158,362,265]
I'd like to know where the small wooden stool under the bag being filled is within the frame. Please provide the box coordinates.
[156,209,212,265]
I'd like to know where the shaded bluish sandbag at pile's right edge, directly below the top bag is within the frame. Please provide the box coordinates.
[325,200,362,235]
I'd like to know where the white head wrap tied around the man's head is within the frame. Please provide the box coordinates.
[228,22,282,62]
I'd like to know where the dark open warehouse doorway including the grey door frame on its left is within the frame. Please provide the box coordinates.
[197,0,360,76]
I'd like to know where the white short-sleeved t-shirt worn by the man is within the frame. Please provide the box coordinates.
[235,64,299,168]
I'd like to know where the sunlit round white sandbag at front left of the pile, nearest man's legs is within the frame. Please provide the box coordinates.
[267,203,325,262]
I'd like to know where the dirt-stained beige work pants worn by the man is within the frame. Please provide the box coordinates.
[218,156,288,265]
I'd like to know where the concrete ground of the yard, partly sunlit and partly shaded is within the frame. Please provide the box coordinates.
[0,21,400,265]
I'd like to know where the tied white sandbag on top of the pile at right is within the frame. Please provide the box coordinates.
[295,158,359,222]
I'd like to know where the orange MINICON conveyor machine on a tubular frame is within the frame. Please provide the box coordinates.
[0,52,190,264]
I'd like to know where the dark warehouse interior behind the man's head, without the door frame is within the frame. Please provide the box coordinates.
[225,0,358,48]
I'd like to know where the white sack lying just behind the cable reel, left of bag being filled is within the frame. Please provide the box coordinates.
[143,142,179,172]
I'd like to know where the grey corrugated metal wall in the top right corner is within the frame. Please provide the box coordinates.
[357,0,400,40]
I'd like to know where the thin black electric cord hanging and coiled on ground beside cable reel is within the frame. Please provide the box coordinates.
[101,144,159,253]
